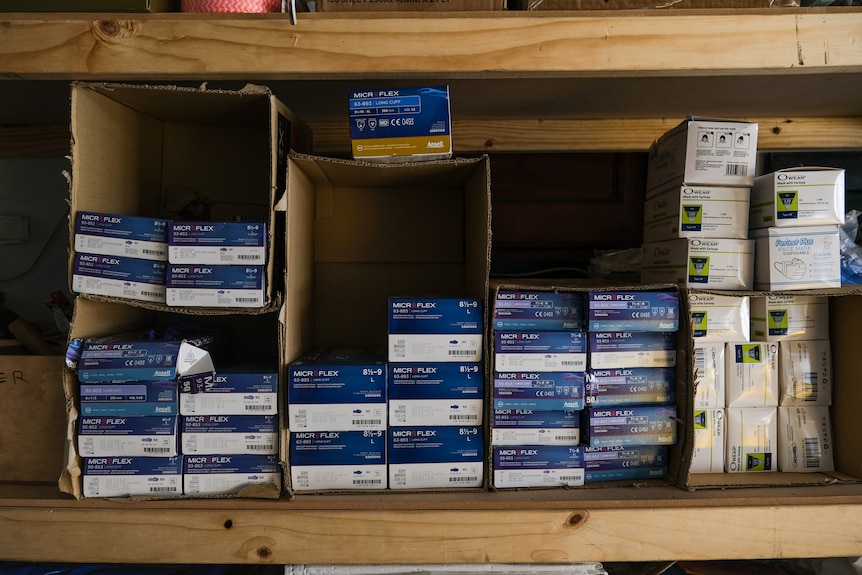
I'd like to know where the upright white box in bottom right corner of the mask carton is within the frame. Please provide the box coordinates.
[778,406,835,473]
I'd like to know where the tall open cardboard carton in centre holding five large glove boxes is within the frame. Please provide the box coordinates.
[280,154,491,493]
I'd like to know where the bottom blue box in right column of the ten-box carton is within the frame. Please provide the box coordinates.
[583,445,668,483]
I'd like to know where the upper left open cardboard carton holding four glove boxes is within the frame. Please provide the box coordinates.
[69,83,311,313]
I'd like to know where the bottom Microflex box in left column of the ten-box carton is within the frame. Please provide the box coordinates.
[493,445,584,489]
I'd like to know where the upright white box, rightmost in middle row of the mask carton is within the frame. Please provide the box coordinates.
[778,339,832,406]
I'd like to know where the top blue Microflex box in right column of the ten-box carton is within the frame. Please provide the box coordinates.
[587,291,679,331]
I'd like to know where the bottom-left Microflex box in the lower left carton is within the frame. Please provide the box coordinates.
[83,456,183,497]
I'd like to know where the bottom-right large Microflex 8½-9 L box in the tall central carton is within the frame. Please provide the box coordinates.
[387,426,485,489]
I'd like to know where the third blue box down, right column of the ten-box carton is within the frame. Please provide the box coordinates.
[585,367,676,407]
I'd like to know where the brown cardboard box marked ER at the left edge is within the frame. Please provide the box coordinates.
[0,355,66,483]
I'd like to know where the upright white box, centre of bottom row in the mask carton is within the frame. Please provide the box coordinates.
[724,407,778,473]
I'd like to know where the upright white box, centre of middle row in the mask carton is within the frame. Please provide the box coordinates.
[725,342,778,408]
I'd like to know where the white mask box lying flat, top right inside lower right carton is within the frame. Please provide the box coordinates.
[751,293,829,341]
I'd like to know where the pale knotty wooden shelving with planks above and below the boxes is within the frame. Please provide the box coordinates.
[0,8,862,564]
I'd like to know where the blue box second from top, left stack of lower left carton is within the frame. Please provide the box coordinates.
[78,380,179,416]
